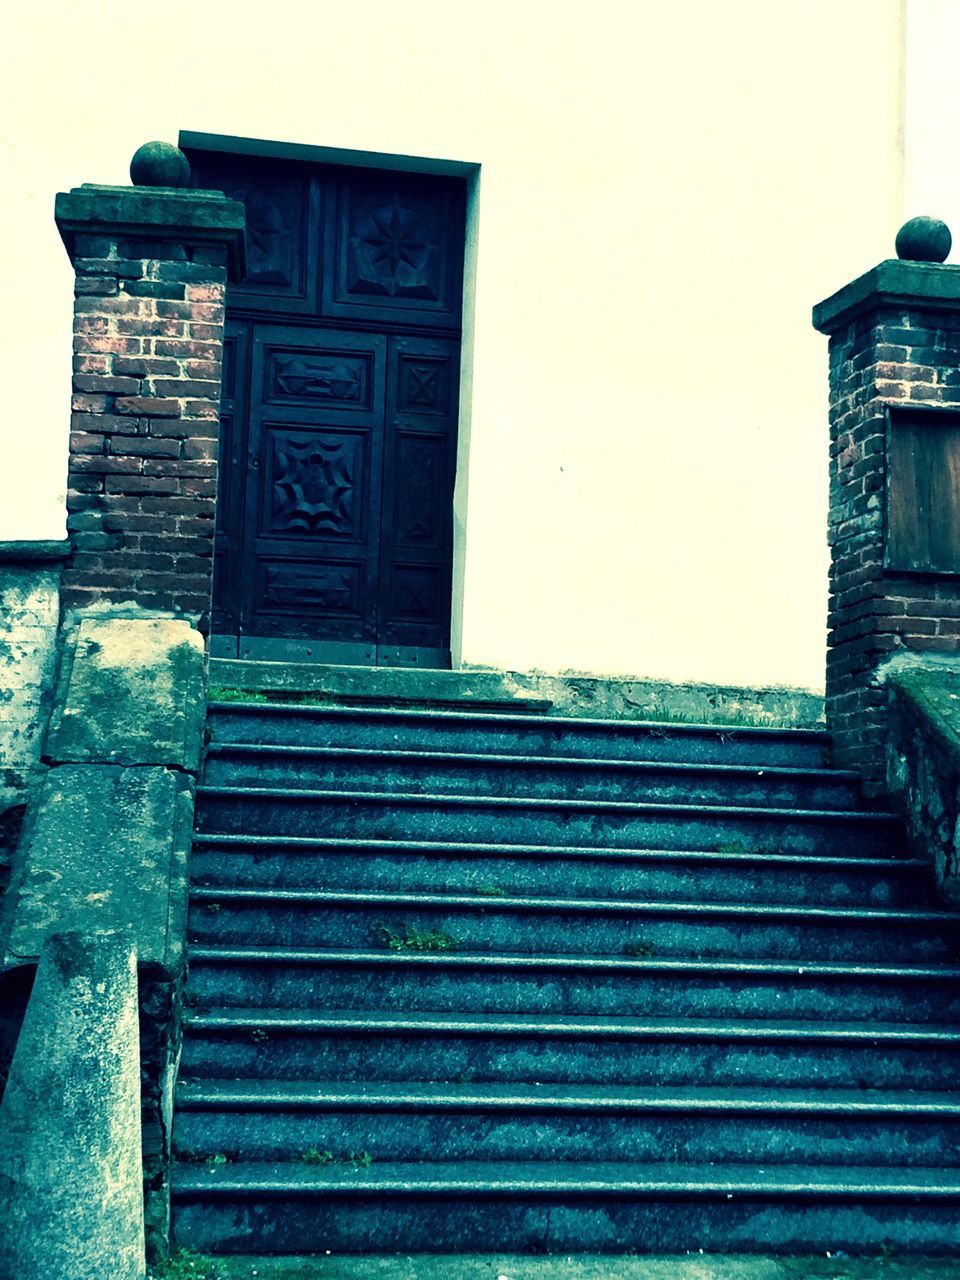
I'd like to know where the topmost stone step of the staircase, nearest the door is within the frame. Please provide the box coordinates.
[209,701,829,768]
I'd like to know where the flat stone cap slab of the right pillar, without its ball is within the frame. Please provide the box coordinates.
[813,257,960,334]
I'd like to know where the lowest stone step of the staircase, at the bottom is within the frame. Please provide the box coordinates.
[173,1161,960,1256]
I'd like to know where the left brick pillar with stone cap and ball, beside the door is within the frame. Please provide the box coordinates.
[56,143,243,628]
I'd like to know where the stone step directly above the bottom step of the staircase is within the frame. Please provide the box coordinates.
[175,1080,960,1169]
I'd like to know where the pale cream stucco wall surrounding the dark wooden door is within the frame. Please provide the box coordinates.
[0,0,926,686]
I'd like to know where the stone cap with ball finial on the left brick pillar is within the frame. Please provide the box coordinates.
[54,142,246,279]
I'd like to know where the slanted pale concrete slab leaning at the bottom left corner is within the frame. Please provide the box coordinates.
[0,932,145,1280]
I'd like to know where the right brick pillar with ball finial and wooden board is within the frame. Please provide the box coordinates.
[813,219,960,794]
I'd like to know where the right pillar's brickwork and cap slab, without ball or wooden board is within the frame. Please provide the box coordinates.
[814,261,960,792]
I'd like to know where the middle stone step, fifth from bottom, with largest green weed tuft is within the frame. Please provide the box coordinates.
[188,888,960,963]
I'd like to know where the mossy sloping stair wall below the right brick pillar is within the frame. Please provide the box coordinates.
[886,664,960,906]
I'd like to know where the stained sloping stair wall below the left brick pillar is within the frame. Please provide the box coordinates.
[0,605,206,1244]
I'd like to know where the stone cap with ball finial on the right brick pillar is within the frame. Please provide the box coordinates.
[813,218,960,334]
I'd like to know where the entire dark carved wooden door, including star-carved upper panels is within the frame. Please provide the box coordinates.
[188,148,465,667]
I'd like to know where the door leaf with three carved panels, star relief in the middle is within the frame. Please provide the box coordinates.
[241,325,387,652]
